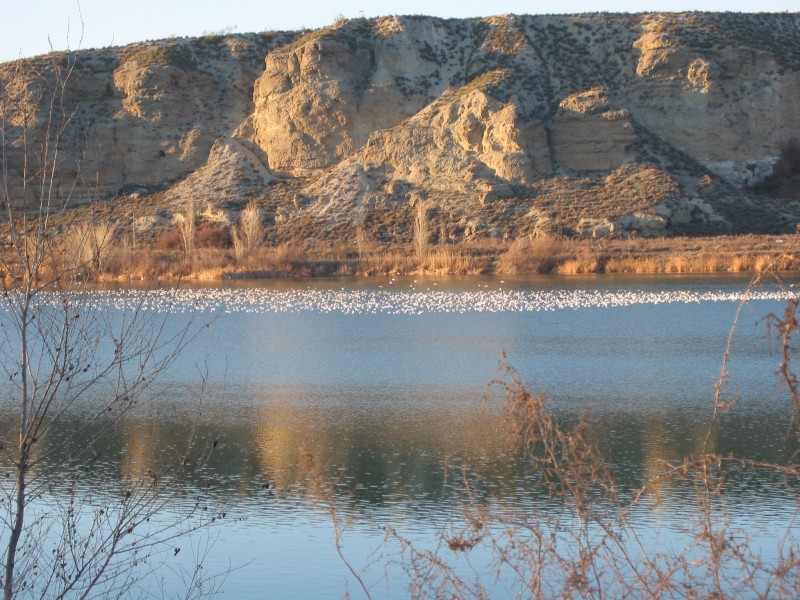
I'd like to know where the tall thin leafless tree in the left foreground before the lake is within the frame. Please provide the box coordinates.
[0,44,216,600]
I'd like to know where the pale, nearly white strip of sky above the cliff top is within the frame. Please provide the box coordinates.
[0,0,800,62]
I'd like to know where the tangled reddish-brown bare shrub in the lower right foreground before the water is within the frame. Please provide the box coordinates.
[310,277,800,599]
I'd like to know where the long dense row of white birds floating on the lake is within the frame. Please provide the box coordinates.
[20,287,797,315]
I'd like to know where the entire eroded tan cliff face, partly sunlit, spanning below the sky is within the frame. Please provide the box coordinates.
[0,13,800,239]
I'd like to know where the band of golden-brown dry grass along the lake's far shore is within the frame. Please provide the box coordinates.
[9,232,800,281]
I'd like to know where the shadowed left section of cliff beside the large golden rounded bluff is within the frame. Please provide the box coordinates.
[0,34,293,202]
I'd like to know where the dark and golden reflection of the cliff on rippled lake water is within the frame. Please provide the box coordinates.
[0,386,789,518]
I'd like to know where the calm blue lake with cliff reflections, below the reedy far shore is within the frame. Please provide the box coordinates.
[2,275,798,598]
